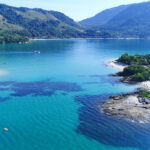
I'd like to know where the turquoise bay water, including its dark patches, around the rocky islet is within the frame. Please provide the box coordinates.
[0,40,150,150]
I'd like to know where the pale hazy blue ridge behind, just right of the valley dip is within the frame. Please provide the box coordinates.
[79,5,129,27]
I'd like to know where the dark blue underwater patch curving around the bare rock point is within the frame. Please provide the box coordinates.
[75,95,150,150]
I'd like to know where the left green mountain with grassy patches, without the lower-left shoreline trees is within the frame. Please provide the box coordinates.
[0,4,83,38]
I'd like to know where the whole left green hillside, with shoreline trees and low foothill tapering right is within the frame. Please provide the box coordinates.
[0,4,118,43]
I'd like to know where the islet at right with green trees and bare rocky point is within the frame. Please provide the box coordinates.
[100,53,150,123]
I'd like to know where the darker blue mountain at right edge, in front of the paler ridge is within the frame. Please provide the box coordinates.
[100,2,150,37]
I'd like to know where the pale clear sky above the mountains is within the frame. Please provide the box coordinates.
[0,0,147,21]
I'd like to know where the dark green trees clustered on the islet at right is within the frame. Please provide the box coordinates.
[118,54,150,82]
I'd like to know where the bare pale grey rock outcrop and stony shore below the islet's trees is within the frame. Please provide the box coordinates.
[100,61,150,123]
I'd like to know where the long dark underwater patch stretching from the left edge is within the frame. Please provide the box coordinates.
[0,81,83,101]
